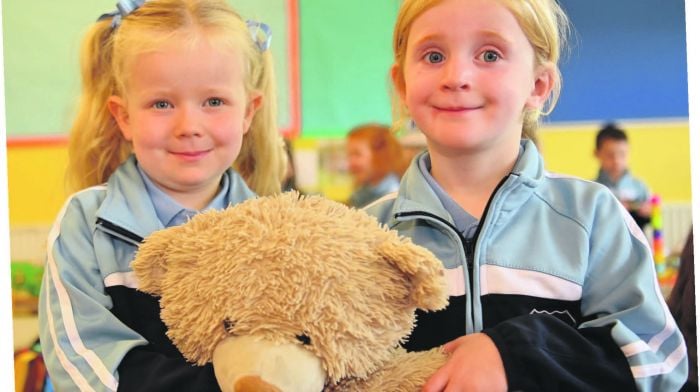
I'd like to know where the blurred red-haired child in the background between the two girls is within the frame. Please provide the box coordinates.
[346,124,407,208]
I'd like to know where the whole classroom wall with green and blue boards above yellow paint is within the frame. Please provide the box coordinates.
[3,0,690,225]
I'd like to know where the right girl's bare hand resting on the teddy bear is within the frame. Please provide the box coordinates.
[423,333,508,392]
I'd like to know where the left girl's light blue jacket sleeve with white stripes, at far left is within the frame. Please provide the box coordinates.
[39,199,218,391]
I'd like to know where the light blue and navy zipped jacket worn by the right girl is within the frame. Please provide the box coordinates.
[367,142,688,391]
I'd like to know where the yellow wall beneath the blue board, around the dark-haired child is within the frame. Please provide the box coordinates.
[539,121,691,202]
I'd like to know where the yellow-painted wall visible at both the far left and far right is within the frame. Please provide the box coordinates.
[7,122,691,226]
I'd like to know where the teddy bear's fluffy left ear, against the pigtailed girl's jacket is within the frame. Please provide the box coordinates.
[131,226,182,295]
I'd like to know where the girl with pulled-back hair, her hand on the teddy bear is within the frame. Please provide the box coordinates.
[367,0,687,392]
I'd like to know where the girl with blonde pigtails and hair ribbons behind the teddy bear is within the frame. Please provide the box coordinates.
[39,0,286,391]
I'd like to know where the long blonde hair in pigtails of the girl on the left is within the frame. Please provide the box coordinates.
[67,0,287,195]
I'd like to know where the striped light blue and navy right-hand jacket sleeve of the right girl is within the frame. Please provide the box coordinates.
[484,192,688,391]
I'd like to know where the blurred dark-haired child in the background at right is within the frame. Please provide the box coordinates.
[595,123,651,228]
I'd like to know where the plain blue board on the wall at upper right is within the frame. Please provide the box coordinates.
[550,0,688,122]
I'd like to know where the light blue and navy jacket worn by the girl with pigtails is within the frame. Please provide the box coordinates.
[39,156,254,391]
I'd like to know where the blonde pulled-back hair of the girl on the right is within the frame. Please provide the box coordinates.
[392,0,570,138]
